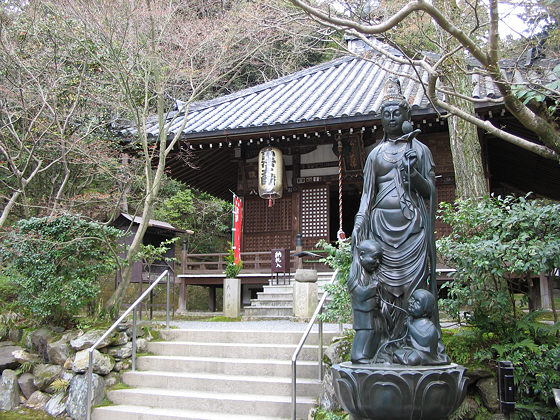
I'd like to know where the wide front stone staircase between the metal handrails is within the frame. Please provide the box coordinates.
[93,329,335,420]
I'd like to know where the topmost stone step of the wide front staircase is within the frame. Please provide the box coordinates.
[155,329,338,345]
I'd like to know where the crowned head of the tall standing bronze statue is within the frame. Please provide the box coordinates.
[380,76,412,136]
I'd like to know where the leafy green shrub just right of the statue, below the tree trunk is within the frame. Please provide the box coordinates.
[437,196,560,335]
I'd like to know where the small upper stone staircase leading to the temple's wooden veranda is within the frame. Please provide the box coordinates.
[242,272,332,321]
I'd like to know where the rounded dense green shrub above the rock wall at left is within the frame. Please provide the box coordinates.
[0,215,122,326]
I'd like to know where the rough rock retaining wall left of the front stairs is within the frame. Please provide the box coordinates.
[0,324,153,420]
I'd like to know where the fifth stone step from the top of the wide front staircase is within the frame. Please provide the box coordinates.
[107,388,316,418]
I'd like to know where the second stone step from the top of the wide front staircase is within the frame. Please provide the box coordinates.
[148,341,319,360]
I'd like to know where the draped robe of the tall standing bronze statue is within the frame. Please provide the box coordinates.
[348,139,435,357]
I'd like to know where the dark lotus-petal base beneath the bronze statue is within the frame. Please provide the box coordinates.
[332,362,468,420]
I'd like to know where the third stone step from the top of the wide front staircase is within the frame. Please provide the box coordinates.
[136,356,319,378]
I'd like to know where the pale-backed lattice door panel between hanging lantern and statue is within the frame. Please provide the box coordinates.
[301,186,329,248]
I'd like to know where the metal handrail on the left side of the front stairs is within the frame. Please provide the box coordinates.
[86,270,170,420]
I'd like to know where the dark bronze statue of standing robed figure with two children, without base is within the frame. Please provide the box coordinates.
[348,78,449,365]
